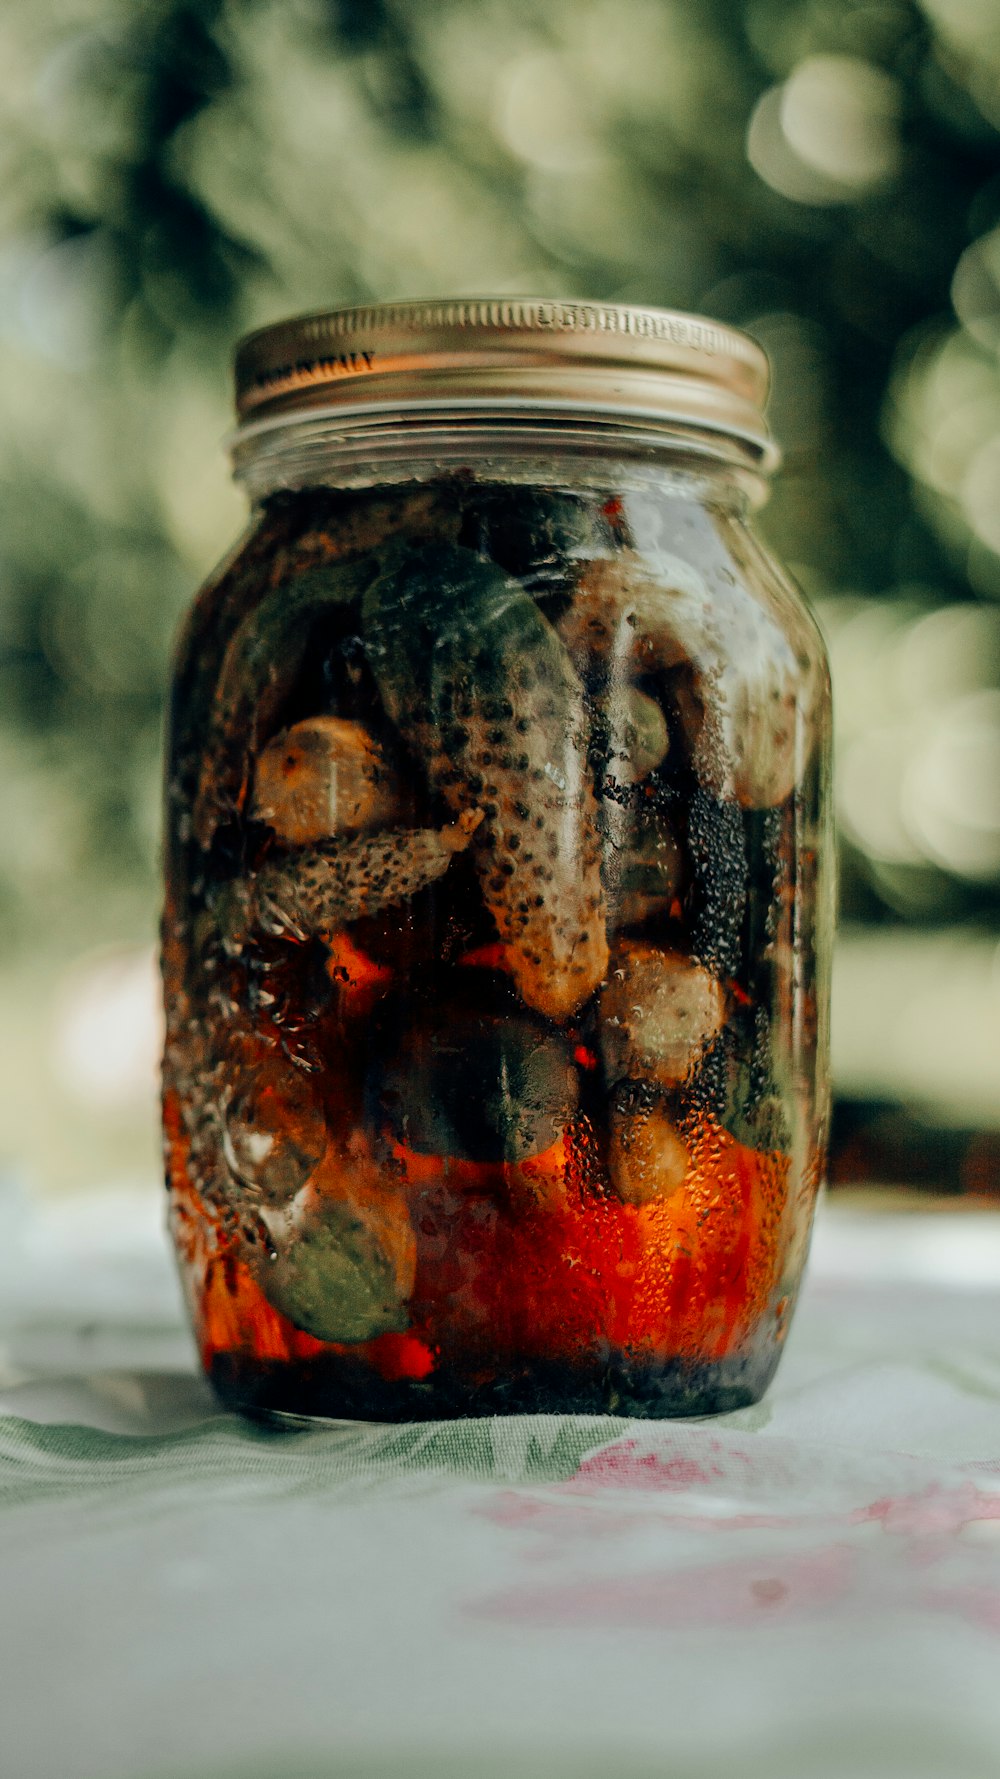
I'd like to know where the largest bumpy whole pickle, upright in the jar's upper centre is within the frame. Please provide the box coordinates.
[361,544,609,1019]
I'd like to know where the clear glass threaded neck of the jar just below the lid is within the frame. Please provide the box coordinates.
[231,407,769,509]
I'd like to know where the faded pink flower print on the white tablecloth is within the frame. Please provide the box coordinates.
[464,1425,1000,1633]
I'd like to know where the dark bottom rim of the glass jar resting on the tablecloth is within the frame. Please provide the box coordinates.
[208,1345,781,1430]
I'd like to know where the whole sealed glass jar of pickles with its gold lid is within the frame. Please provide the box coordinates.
[164,301,831,1420]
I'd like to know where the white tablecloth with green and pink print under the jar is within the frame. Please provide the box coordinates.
[0,1190,1000,1779]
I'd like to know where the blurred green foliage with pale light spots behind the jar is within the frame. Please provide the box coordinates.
[0,0,1000,1192]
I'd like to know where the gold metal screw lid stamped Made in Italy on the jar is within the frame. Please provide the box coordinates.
[235,297,778,466]
